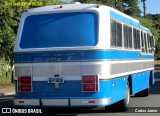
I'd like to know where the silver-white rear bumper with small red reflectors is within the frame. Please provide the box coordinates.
[14,98,111,107]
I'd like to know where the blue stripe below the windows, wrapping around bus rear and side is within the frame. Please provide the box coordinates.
[14,50,154,63]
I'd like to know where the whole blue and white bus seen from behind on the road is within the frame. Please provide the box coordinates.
[14,4,154,107]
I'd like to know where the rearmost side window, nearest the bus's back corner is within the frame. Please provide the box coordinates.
[111,20,122,47]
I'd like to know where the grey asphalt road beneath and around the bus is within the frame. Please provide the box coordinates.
[0,71,160,116]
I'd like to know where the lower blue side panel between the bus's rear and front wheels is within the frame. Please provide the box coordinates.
[132,71,150,94]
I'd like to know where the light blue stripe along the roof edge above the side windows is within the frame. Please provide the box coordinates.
[110,11,151,33]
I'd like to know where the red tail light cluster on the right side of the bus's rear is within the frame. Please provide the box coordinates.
[82,75,98,92]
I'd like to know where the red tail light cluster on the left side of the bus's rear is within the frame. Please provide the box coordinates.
[18,77,32,92]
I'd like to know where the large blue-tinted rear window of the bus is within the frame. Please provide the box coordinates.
[20,12,98,49]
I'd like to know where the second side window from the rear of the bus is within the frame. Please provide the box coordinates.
[123,25,132,48]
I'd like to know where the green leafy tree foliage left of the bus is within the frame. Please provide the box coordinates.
[0,0,62,66]
